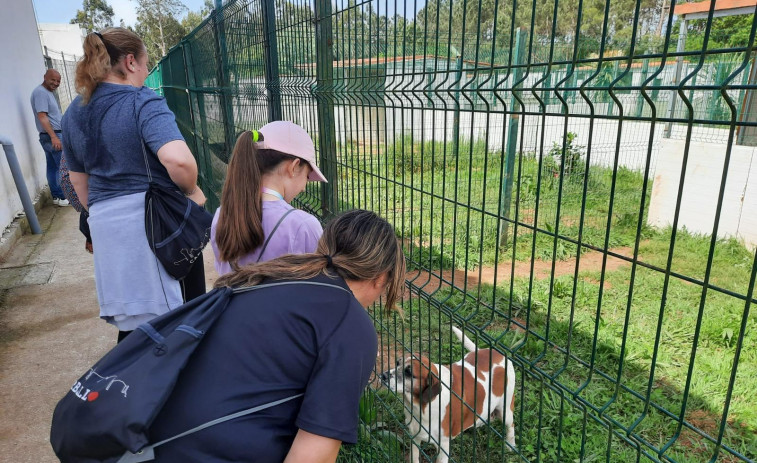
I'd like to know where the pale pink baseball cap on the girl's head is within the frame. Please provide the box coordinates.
[258,121,328,183]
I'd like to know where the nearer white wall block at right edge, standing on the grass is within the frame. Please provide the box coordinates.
[648,139,757,249]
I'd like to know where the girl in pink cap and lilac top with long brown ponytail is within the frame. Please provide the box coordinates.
[210,121,326,275]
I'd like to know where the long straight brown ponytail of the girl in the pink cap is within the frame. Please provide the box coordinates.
[216,131,297,270]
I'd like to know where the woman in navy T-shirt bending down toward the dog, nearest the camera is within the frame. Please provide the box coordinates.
[151,210,405,462]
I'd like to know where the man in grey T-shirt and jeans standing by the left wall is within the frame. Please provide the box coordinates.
[31,69,68,206]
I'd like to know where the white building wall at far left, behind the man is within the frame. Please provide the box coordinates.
[0,0,47,236]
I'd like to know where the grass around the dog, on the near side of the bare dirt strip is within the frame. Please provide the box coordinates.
[352,241,757,463]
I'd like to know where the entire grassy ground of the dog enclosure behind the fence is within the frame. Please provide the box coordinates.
[339,137,757,463]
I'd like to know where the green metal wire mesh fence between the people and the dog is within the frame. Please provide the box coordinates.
[153,0,757,462]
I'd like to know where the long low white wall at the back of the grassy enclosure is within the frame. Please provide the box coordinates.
[326,102,728,175]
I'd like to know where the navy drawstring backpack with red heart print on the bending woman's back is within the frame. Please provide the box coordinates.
[50,281,347,463]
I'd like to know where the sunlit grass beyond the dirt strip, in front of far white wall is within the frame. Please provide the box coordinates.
[337,136,651,269]
